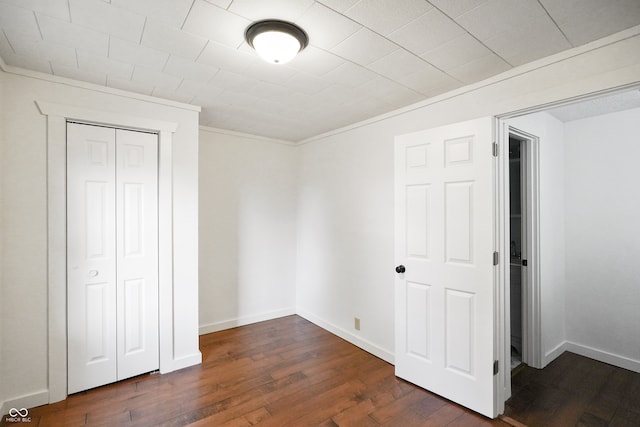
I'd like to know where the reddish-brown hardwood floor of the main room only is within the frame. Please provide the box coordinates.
[2,316,508,427]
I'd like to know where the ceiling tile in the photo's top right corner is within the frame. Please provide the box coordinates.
[540,0,640,46]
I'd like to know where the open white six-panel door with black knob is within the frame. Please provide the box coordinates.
[395,118,497,417]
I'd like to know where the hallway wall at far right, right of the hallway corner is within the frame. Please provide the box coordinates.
[565,109,640,371]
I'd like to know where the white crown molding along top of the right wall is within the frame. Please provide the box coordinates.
[297,25,640,145]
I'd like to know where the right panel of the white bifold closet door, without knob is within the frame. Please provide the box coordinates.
[116,129,159,379]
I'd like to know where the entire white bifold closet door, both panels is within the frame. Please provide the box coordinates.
[67,123,159,393]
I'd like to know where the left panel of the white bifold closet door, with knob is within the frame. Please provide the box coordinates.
[67,123,116,393]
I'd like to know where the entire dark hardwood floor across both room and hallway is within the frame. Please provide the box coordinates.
[6,316,640,427]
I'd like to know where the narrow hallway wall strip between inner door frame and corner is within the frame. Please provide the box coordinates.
[507,113,566,366]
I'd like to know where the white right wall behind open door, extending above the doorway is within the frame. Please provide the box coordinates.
[297,28,640,360]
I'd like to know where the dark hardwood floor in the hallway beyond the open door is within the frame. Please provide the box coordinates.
[505,352,640,427]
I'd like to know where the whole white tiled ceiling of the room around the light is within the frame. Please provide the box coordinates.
[0,0,640,141]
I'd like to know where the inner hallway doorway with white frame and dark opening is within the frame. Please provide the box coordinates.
[499,121,543,400]
